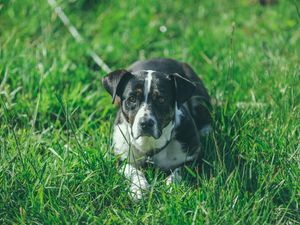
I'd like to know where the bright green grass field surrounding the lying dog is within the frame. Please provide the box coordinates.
[0,0,300,224]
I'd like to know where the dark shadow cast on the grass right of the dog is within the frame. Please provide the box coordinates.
[186,104,258,192]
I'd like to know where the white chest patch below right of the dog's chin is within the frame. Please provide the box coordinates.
[151,140,194,170]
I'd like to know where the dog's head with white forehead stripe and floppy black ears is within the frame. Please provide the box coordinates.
[102,70,195,148]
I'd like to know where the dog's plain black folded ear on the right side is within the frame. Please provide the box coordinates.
[170,73,196,106]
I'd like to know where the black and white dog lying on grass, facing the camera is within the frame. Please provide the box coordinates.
[102,59,211,199]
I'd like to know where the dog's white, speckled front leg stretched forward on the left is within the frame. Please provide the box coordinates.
[123,164,149,200]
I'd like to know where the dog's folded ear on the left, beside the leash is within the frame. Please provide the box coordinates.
[102,69,133,103]
